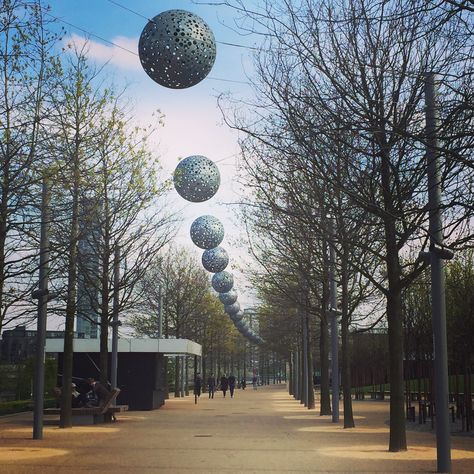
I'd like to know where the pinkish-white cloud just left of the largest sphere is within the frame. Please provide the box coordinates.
[64,33,141,71]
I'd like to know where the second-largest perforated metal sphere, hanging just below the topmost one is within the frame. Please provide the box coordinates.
[173,155,221,202]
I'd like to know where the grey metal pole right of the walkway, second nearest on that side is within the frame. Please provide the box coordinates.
[329,217,339,423]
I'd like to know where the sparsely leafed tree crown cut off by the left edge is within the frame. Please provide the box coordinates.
[0,0,57,331]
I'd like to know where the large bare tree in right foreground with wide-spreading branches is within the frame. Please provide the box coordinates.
[217,0,473,451]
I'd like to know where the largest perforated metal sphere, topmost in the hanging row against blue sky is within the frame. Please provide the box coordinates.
[138,10,216,89]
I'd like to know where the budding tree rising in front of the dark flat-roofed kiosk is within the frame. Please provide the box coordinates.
[78,98,175,383]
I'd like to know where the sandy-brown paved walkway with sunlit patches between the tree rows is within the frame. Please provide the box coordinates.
[0,385,474,474]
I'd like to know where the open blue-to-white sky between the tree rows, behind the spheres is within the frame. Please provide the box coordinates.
[42,0,262,326]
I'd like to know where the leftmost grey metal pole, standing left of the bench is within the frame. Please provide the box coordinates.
[33,177,51,439]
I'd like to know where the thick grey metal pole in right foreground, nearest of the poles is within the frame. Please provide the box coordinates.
[425,73,451,472]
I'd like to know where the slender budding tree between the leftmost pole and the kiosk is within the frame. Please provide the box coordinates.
[48,48,110,428]
